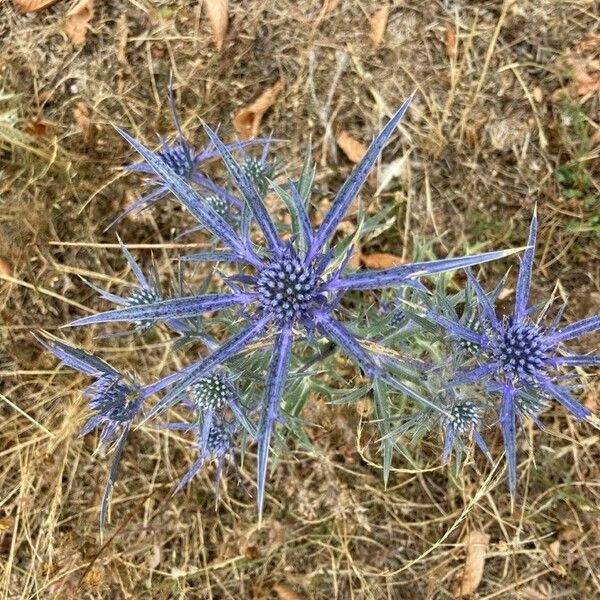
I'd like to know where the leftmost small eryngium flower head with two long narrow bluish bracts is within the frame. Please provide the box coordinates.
[36,333,147,530]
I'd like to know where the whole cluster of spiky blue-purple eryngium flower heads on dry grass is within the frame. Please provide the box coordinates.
[40,85,600,524]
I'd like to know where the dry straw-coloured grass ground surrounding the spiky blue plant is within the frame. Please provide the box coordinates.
[0,0,600,600]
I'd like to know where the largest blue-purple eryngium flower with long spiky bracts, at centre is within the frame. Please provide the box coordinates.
[64,96,513,517]
